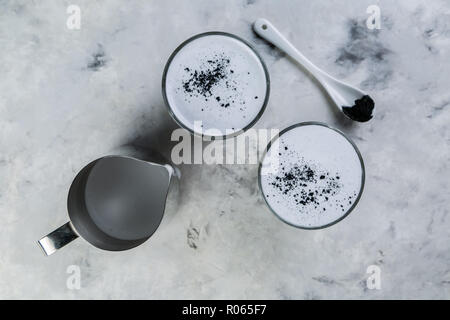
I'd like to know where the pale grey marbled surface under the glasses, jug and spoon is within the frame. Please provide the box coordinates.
[0,0,450,299]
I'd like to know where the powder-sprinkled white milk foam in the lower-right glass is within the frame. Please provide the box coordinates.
[261,124,363,228]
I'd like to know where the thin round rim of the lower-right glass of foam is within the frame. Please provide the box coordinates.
[258,121,366,230]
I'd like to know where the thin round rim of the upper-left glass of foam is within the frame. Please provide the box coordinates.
[162,31,270,140]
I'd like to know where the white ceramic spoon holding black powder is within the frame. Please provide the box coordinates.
[253,18,375,122]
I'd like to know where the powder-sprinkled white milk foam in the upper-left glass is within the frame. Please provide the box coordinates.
[165,35,268,136]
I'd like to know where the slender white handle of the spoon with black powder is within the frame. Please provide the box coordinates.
[253,18,328,82]
